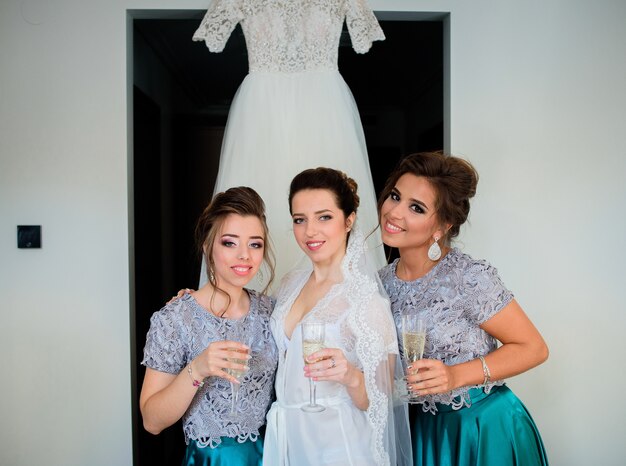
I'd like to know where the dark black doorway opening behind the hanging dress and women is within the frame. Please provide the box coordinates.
[129,11,448,466]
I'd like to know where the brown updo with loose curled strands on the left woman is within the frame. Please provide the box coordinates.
[195,186,275,306]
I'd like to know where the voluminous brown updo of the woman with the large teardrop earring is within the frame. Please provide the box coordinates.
[378,152,478,244]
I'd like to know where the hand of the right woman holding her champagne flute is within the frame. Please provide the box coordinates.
[406,359,457,396]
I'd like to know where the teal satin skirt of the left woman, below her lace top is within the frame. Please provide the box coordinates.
[183,437,263,466]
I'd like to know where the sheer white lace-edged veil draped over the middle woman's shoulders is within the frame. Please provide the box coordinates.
[272,230,413,466]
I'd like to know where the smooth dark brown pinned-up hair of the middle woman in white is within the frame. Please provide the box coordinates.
[289,167,360,217]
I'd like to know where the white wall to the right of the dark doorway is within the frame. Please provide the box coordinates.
[380,0,626,466]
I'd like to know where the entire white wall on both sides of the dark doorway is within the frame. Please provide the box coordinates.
[0,0,626,466]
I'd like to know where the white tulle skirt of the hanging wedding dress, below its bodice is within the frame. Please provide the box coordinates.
[201,70,385,289]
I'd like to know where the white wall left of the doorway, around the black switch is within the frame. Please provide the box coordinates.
[0,1,131,465]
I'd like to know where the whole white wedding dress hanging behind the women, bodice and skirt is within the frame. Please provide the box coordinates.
[193,0,385,289]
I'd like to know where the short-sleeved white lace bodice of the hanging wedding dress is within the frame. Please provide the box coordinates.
[193,0,385,73]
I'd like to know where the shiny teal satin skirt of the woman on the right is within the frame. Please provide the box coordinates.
[410,386,548,466]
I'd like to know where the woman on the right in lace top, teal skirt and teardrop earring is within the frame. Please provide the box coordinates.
[378,153,548,466]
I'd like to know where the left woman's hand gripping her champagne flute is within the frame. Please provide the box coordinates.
[191,340,251,384]
